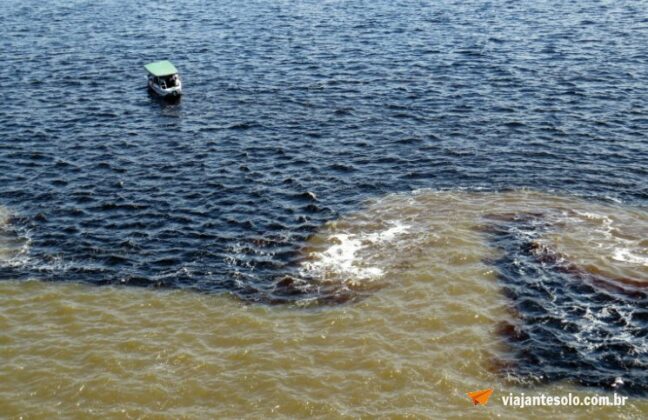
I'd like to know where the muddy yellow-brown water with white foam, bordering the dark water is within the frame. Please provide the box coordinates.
[0,191,648,418]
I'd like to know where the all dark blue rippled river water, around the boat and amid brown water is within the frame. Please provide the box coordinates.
[0,0,648,400]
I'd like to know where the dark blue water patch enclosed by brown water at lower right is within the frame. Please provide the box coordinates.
[486,214,648,396]
